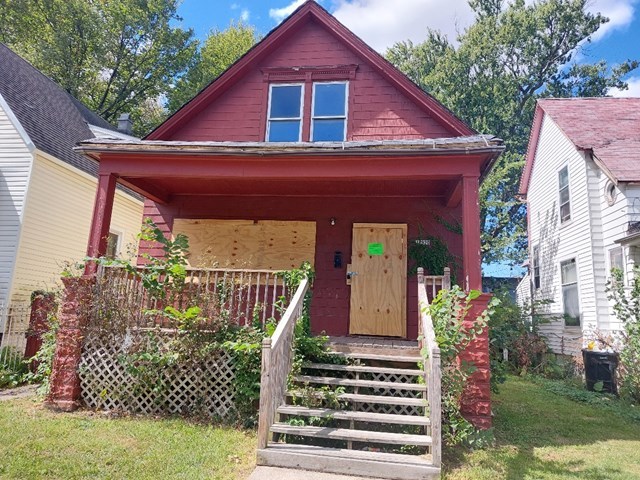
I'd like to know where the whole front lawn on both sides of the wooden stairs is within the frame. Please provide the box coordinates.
[0,377,640,480]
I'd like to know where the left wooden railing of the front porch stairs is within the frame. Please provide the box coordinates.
[258,278,309,449]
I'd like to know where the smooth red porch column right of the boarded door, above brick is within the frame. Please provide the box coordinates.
[462,175,482,291]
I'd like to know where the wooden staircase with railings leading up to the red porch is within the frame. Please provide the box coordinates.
[257,269,448,480]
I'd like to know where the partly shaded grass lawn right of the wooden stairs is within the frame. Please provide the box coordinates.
[444,377,640,480]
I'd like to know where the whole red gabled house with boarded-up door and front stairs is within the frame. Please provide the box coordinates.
[50,1,504,479]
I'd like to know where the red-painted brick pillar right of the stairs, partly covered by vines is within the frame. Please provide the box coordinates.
[460,294,491,429]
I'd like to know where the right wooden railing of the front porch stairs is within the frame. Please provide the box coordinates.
[418,267,442,467]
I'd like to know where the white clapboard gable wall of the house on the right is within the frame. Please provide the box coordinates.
[527,115,601,353]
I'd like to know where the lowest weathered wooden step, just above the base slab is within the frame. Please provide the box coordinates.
[271,423,431,447]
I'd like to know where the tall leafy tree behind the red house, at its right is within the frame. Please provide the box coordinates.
[387,0,638,263]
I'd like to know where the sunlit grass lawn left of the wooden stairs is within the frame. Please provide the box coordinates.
[0,399,256,479]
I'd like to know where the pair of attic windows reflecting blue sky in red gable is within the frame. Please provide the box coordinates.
[266,81,348,142]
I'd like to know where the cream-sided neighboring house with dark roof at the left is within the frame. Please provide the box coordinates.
[0,44,142,344]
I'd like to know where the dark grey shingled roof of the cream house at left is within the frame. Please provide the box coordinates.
[0,43,115,176]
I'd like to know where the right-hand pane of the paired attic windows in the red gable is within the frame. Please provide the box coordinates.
[311,82,347,142]
